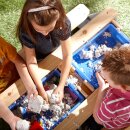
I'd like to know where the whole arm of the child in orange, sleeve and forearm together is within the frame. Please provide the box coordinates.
[0,37,37,96]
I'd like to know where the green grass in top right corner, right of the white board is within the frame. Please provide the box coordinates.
[87,0,130,37]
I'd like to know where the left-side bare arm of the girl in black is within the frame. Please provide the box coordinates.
[24,46,48,102]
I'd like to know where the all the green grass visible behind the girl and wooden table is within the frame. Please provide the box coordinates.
[0,0,130,50]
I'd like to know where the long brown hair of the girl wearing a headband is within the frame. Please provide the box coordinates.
[16,0,66,43]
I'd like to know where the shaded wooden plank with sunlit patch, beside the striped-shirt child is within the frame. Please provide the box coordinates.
[54,89,98,130]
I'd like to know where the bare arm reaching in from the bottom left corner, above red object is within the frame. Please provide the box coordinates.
[0,101,20,130]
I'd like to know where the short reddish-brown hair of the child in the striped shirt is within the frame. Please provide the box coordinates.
[102,46,130,86]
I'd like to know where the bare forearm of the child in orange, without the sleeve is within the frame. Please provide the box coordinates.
[12,54,38,97]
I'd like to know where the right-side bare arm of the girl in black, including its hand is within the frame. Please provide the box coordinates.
[54,38,72,101]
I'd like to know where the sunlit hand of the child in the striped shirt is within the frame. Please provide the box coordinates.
[96,72,109,90]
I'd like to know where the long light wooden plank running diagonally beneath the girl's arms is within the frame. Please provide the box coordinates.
[0,9,117,106]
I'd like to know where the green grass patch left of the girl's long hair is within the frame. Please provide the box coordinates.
[0,0,24,50]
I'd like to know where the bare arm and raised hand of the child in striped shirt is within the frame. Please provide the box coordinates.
[93,72,109,124]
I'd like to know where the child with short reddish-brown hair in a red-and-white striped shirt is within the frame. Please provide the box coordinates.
[93,46,130,130]
